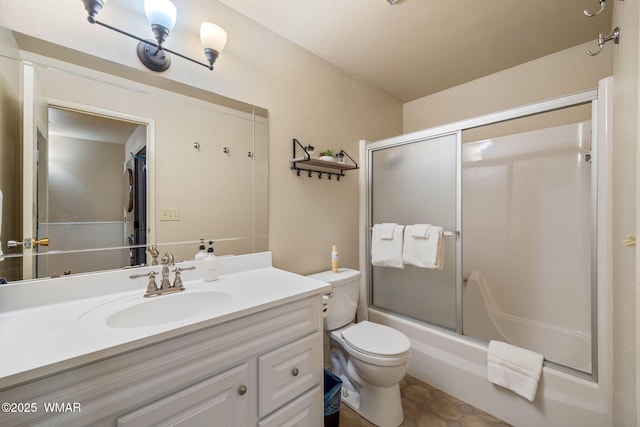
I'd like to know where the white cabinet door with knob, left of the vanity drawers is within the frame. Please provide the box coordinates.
[118,363,250,427]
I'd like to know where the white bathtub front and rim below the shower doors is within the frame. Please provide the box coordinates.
[368,307,613,427]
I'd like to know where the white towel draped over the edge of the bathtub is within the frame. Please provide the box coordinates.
[487,341,544,402]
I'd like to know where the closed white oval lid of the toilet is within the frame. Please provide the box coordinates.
[342,320,411,356]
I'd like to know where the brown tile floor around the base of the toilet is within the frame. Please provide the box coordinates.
[340,375,510,427]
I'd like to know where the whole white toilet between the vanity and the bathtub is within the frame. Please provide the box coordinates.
[308,268,411,427]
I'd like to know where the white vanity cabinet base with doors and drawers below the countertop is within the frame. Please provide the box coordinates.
[0,293,323,427]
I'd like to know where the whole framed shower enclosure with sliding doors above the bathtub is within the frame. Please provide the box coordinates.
[363,91,598,380]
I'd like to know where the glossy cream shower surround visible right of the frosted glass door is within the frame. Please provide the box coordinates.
[462,118,595,373]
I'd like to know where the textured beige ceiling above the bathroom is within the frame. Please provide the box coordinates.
[220,0,614,101]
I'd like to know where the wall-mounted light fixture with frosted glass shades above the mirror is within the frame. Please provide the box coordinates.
[82,0,227,71]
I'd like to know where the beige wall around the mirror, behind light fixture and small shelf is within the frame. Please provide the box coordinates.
[0,0,402,274]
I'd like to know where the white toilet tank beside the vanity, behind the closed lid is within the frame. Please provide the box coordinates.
[308,268,360,331]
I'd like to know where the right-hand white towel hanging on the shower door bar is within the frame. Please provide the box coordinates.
[402,224,444,270]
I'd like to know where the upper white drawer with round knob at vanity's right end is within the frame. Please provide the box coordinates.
[258,332,322,417]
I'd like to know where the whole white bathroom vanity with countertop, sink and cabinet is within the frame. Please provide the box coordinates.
[0,253,329,427]
